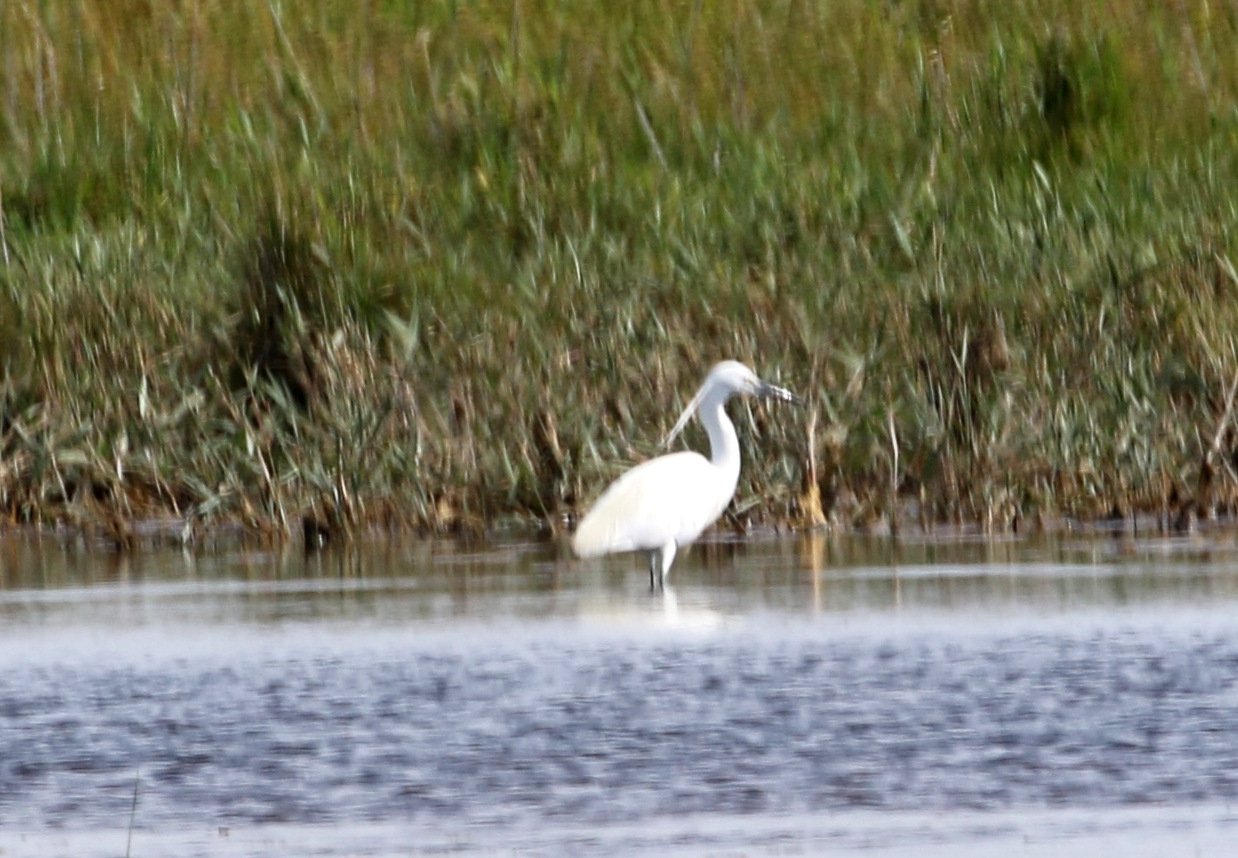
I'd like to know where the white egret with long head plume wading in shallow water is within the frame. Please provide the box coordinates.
[572,360,801,589]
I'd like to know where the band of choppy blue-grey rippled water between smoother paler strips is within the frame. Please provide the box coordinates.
[0,616,1238,828]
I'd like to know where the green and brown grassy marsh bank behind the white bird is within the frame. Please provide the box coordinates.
[0,0,1238,544]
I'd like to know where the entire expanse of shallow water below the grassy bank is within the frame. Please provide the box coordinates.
[0,535,1238,856]
